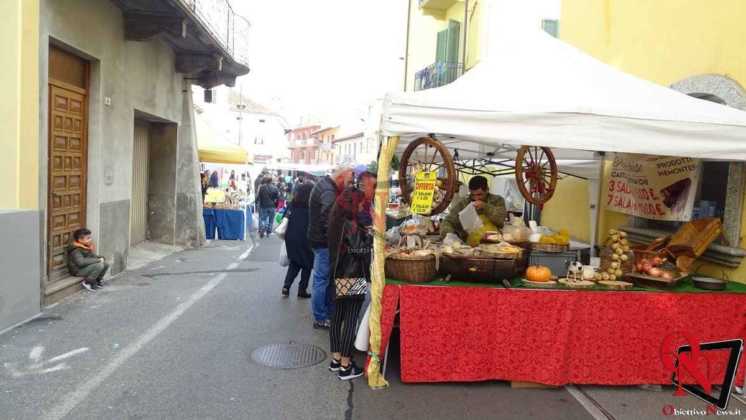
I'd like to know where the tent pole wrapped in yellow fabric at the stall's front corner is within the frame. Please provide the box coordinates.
[366,136,399,389]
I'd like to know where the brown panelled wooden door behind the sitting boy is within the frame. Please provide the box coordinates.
[47,47,88,282]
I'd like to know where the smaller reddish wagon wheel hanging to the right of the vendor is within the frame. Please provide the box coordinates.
[515,146,557,206]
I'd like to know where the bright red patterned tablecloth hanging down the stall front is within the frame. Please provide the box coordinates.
[381,284,746,385]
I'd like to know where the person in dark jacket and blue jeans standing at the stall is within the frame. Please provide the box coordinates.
[308,167,353,328]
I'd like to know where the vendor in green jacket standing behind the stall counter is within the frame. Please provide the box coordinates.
[440,176,506,246]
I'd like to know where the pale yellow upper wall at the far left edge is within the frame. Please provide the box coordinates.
[0,0,39,209]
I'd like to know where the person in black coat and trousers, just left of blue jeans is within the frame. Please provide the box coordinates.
[282,183,313,299]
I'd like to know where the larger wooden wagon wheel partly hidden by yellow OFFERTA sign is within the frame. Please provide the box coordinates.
[399,137,456,215]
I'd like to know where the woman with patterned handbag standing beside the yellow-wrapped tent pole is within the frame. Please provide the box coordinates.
[328,174,375,380]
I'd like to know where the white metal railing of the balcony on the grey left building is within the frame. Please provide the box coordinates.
[178,0,251,66]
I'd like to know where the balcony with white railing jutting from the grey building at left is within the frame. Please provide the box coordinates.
[113,0,250,89]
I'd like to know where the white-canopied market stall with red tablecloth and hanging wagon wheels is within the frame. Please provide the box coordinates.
[367,23,746,388]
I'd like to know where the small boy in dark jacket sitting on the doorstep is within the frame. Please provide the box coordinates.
[67,228,109,292]
